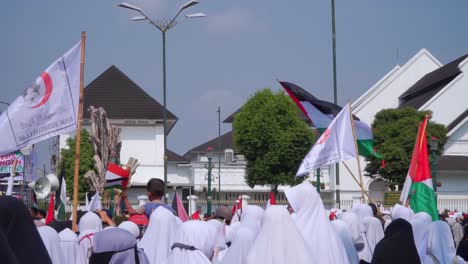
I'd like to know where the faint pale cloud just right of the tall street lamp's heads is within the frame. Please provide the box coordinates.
[206,8,267,34]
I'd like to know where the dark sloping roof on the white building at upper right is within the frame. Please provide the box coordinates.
[399,54,468,109]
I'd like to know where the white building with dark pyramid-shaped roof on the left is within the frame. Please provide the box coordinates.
[60,66,191,201]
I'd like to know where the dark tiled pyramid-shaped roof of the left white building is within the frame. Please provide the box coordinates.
[83,65,177,123]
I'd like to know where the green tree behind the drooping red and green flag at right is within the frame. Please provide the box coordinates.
[365,108,447,189]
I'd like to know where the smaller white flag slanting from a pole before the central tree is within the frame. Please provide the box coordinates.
[296,105,357,176]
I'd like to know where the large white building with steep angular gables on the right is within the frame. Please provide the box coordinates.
[340,49,468,205]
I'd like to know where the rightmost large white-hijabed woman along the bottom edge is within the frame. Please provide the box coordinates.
[427,221,466,264]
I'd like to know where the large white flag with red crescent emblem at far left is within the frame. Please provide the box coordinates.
[0,42,81,155]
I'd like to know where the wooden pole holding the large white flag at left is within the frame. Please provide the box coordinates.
[72,31,86,232]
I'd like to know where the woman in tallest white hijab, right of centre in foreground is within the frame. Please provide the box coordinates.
[285,182,349,264]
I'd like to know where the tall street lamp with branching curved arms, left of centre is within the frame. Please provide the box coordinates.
[119,0,206,202]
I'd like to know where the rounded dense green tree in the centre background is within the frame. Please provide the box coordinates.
[233,89,314,193]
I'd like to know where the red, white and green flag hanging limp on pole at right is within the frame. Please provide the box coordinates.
[400,116,439,221]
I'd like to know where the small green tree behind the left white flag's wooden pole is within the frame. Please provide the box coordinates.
[59,129,95,200]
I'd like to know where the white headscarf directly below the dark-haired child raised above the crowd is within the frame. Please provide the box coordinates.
[138,206,179,263]
